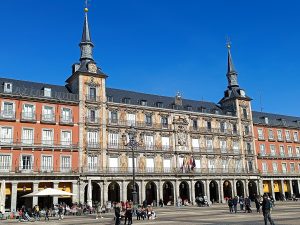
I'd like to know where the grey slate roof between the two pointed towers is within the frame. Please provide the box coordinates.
[106,88,223,114]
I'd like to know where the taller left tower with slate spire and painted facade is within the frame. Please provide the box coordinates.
[66,8,107,193]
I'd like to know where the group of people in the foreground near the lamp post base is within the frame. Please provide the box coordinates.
[113,200,156,225]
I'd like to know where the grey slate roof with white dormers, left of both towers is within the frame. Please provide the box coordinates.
[0,78,78,101]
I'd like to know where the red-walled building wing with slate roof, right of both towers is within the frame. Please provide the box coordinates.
[253,112,300,200]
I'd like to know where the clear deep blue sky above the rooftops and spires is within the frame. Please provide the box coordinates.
[0,0,300,116]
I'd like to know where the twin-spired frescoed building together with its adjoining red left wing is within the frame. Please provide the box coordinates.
[0,7,296,210]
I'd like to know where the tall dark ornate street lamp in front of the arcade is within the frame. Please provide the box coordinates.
[122,126,139,205]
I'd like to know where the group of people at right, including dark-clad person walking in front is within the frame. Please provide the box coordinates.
[227,194,275,225]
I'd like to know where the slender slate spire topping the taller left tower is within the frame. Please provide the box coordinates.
[79,8,94,63]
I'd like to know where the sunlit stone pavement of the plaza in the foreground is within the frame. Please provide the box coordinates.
[0,202,300,225]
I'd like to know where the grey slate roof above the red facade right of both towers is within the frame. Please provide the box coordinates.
[252,111,300,128]
